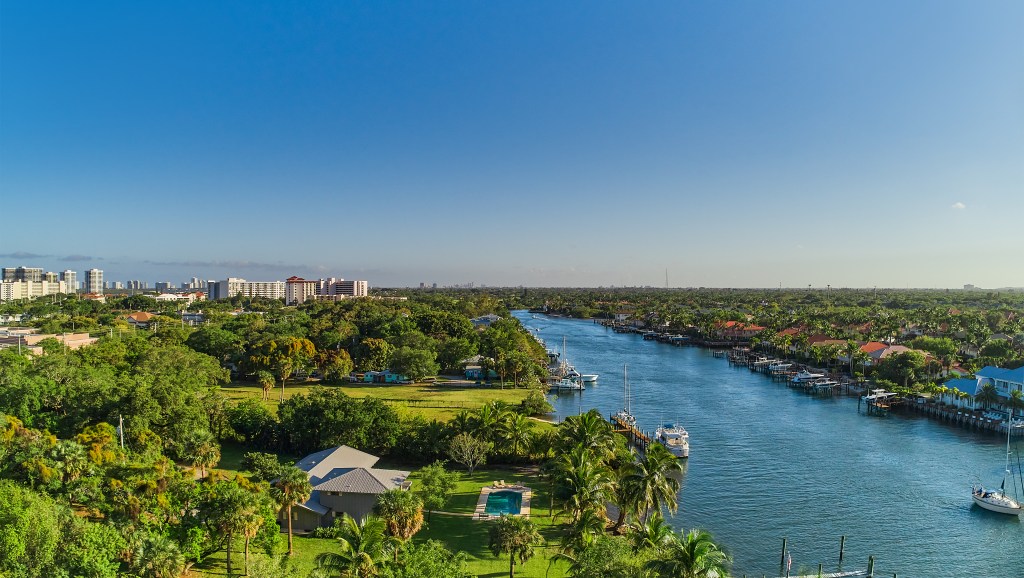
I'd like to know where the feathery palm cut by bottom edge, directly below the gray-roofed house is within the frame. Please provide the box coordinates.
[316,513,396,578]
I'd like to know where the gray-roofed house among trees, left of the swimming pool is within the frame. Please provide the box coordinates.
[278,446,411,532]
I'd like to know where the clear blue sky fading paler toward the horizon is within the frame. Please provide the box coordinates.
[0,0,1024,287]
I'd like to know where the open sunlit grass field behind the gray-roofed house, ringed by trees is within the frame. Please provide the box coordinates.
[221,381,527,421]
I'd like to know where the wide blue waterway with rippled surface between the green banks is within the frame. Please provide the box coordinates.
[515,312,1024,578]
